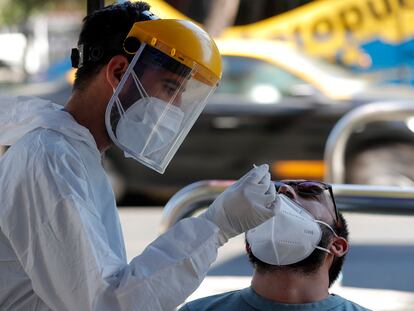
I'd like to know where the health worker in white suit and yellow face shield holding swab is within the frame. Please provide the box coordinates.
[0,2,276,311]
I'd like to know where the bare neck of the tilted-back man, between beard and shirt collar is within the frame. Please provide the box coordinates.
[252,270,329,304]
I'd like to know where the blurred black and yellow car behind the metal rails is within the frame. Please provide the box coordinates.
[102,39,414,203]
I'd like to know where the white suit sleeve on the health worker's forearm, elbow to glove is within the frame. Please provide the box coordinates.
[114,218,218,310]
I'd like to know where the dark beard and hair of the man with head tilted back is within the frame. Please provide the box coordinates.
[245,213,349,286]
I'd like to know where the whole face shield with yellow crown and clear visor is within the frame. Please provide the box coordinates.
[105,20,221,173]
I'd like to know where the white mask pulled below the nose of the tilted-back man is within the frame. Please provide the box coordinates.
[246,194,335,266]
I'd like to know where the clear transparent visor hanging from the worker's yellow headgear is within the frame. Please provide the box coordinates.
[105,43,218,173]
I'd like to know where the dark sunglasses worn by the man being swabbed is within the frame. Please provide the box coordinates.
[273,180,339,225]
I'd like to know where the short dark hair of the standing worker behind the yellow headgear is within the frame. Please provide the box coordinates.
[73,1,150,89]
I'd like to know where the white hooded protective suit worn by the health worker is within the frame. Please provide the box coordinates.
[0,98,219,311]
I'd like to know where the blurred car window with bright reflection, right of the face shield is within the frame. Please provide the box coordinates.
[216,56,307,103]
